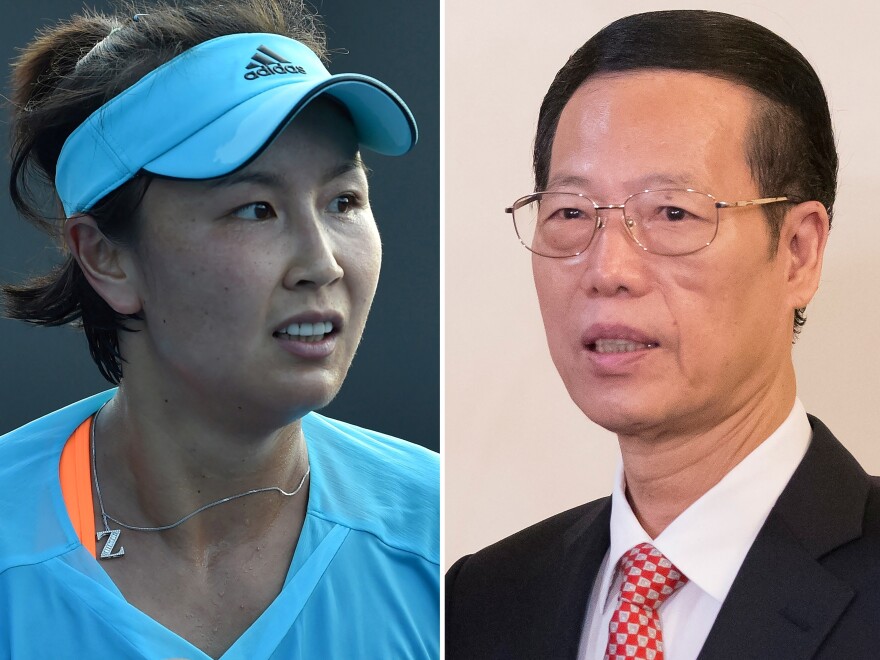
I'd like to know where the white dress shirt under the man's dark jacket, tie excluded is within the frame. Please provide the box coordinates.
[578,399,812,660]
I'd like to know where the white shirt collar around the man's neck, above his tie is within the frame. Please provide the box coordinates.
[599,399,812,609]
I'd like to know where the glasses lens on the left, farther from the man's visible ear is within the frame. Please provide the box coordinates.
[513,193,596,257]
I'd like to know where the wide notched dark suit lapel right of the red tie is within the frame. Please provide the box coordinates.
[699,417,870,660]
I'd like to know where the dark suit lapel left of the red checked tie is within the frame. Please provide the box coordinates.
[548,497,611,658]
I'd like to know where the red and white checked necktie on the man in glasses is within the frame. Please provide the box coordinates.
[605,543,687,660]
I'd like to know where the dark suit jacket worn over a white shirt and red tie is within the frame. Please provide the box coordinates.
[446,417,880,660]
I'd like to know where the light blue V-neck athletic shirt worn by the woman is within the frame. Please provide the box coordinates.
[0,390,440,660]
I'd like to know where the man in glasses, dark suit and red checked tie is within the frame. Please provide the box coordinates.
[446,11,880,660]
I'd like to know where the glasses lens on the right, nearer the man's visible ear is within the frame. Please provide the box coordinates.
[624,190,718,255]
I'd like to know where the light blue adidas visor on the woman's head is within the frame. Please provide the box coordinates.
[55,34,418,217]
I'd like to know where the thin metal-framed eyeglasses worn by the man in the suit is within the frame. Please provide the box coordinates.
[504,189,796,258]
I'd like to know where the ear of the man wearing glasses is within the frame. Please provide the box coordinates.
[779,201,830,309]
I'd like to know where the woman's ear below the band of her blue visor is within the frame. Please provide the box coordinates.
[64,215,142,314]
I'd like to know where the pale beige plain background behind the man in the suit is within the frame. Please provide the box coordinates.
[444,0,880,566]
